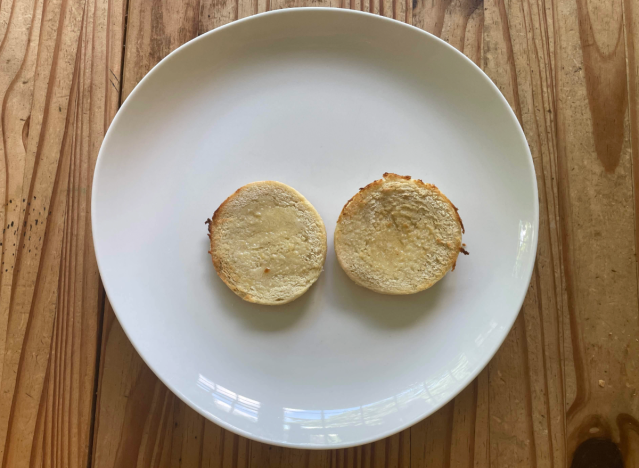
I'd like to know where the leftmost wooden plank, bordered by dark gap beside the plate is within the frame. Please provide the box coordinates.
[0,0,124,460]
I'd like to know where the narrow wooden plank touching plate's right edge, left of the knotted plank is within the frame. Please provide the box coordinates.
[484,2,565,466]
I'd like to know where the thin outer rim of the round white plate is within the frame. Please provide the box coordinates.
[90,7,539,450]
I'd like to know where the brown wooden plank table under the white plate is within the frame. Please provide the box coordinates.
[0,0,639,468]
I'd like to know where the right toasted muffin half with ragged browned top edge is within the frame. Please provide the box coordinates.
[335,173,463,294]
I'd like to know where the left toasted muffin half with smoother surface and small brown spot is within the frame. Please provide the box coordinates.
[207,181,326,305]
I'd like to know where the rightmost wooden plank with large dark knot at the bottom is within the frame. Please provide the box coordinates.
[556,1,639,466]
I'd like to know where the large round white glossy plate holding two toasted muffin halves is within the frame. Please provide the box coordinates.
[92,9,538,448]
